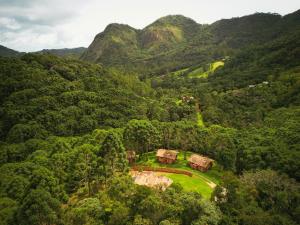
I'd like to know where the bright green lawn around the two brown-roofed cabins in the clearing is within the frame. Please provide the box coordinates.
[137,151,222,198]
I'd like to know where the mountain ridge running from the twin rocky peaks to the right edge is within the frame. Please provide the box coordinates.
[81,10,300,74]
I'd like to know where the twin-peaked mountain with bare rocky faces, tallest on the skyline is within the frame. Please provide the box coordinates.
[81,15,202,72]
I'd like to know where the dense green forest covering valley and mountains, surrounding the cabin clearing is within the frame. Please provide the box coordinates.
[0,10,300,225]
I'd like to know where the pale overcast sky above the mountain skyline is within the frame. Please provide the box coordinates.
[0,0,300,52]
